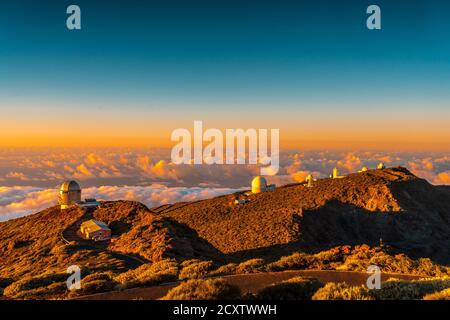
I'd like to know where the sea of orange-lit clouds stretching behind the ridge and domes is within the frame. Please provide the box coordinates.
[0,149,450,221]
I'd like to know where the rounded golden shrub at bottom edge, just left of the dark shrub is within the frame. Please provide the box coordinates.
[162,279,241,300]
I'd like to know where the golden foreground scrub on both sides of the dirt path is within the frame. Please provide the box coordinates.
[0,246,450,300]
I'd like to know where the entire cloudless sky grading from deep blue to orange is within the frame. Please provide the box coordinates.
[0,0,450,150]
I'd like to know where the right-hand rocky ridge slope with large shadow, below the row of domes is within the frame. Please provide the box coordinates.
[159,168,450,261]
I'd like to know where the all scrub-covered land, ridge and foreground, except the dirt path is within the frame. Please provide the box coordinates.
[0,168,450,299]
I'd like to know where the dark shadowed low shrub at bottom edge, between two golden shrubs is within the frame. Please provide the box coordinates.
[256,277,323,300]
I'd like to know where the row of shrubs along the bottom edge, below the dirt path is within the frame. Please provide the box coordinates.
[163,277,450,300]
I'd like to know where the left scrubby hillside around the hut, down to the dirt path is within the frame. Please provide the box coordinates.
[0,201,220,299]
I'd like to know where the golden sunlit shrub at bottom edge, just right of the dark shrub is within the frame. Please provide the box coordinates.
[312,282,374,300]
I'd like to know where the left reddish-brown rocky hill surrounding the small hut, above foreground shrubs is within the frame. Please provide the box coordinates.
[0,201,220,280]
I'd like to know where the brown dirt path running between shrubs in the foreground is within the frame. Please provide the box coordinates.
[72,270,421,300]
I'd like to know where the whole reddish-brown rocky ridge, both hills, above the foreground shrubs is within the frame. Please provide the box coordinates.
[0,168,450,280]
